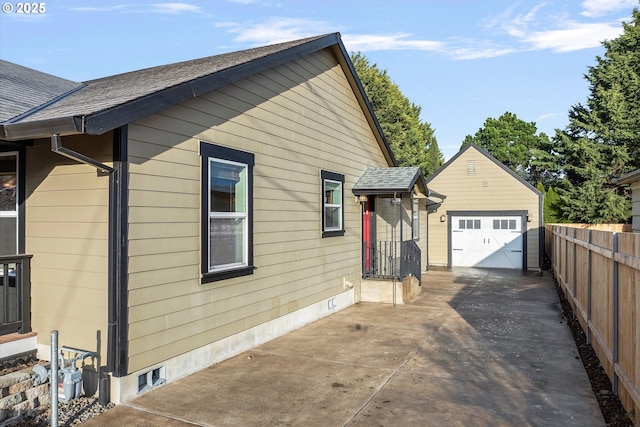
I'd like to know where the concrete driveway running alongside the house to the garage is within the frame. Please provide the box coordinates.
[83,269,605,427]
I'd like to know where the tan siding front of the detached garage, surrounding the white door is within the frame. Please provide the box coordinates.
[428,148,542,269]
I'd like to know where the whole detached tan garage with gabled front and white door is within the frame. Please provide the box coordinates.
[427,144,544,270]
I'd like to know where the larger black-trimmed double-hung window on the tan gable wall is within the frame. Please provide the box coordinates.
[200,142,255,283]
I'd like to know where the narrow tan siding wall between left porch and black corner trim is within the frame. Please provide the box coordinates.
[25,133,113,357]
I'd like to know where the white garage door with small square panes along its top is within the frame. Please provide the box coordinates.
[451,216,524,269]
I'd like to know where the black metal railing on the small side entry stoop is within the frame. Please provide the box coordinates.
[362,240,421,280]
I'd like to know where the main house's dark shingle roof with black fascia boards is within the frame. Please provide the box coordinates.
[0,33,395,150]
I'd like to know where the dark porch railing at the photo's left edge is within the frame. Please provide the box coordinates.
[0,255,32,335]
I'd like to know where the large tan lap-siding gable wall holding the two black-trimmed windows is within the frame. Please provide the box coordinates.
[123,50,388,372]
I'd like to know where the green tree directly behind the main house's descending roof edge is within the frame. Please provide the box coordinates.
[351,52,444,176]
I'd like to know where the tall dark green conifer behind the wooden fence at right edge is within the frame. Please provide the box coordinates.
[554,9,640,223]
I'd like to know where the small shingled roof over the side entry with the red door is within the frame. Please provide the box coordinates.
[353,166,426,195]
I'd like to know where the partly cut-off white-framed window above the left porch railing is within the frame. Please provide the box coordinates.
[0,152,18,255]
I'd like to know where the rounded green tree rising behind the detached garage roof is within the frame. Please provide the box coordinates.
[462,111,558,186]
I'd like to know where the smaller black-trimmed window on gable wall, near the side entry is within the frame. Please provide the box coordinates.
[320,171,344,237]
